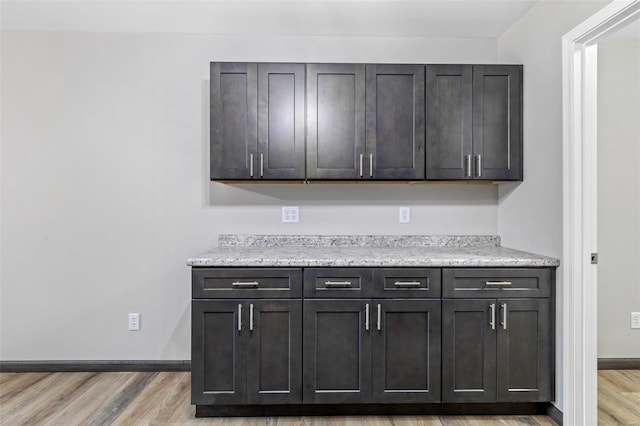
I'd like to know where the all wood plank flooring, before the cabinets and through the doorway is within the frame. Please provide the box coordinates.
[0,370,624,426]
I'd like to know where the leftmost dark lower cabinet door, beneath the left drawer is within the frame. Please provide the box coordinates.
[191,300,249,404]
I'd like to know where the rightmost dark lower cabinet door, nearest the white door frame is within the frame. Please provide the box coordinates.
[497,299,554,402]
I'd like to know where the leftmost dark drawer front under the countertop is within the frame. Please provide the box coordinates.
[192,268,302,299]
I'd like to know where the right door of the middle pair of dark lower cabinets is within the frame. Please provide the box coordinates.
[371,299,441,403]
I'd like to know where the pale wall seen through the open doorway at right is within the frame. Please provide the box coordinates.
[598,39,640,358]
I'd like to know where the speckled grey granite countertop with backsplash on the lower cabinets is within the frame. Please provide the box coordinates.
[187,235,560,267]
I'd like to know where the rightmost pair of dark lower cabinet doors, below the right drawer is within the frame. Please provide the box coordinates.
[442,299,554,402]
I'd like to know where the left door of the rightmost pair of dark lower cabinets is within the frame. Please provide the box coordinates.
[442,299,498,402]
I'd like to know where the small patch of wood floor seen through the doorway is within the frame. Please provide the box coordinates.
[598,370,640,426]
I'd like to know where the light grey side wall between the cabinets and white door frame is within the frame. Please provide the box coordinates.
[498,1,607,409]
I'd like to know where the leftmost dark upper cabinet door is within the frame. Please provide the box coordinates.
[210,62,258,180]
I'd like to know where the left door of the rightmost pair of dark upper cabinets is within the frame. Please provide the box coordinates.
[426,65,473,180]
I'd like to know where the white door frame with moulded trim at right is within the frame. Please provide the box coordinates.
[562,0,640,425]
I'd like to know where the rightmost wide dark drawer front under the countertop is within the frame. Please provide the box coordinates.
[442,268,555,298]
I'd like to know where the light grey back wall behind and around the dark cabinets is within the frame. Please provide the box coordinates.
[0,31,498,360]
